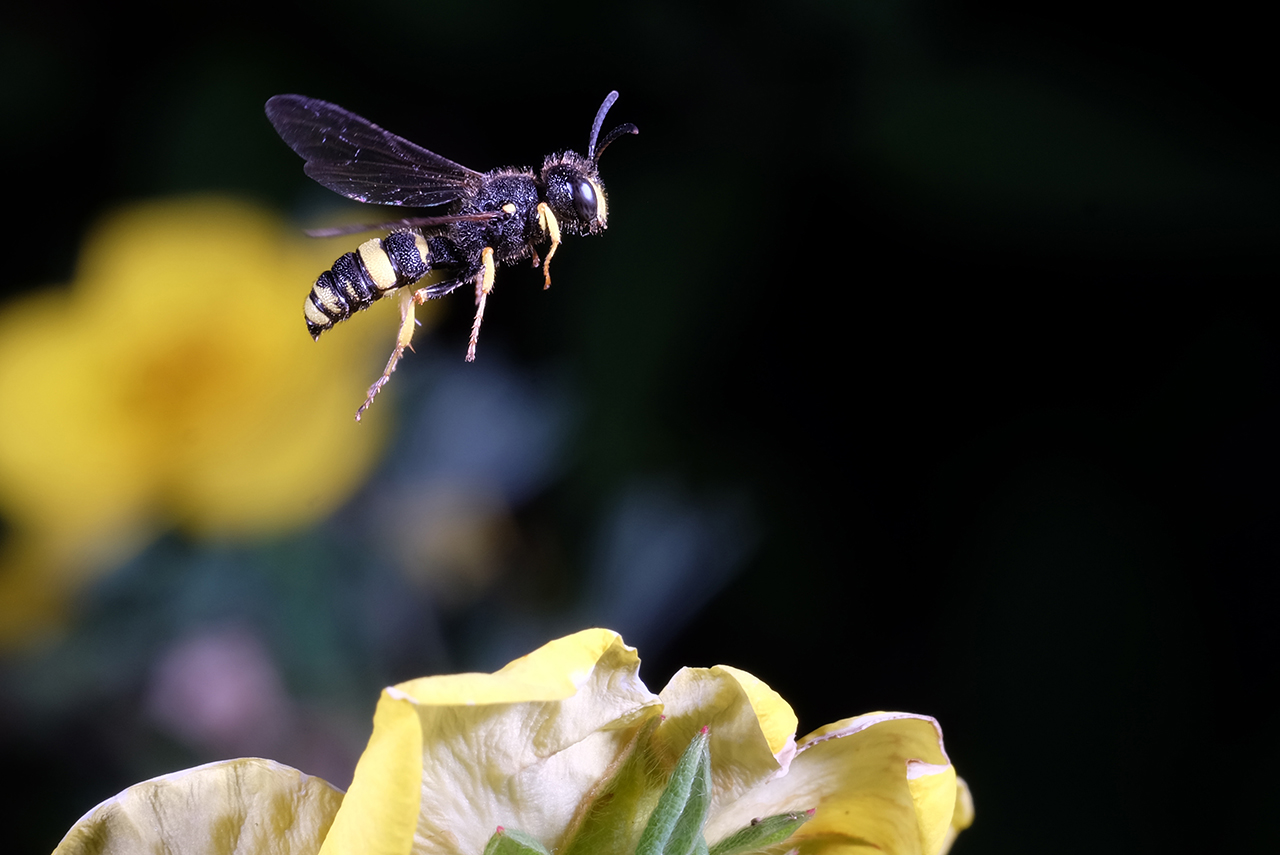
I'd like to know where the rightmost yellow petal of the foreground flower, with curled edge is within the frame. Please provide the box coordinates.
[707,713,956,855]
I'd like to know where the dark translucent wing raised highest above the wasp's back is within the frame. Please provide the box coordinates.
[266,95,481,207]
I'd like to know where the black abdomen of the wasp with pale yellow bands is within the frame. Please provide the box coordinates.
[302,232,431,338]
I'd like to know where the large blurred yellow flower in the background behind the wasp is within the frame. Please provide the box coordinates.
[0,198,407,645]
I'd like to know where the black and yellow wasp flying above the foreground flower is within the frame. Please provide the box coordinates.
[266,92,639,421]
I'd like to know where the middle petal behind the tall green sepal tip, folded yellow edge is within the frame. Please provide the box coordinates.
[654,666,796,831]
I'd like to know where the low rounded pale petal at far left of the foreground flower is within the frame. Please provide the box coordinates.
[54,759,342,855]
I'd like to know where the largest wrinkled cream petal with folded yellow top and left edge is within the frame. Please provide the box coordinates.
[323,630,660,855]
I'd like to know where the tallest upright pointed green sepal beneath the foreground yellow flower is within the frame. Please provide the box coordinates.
[635,727,712,855]
